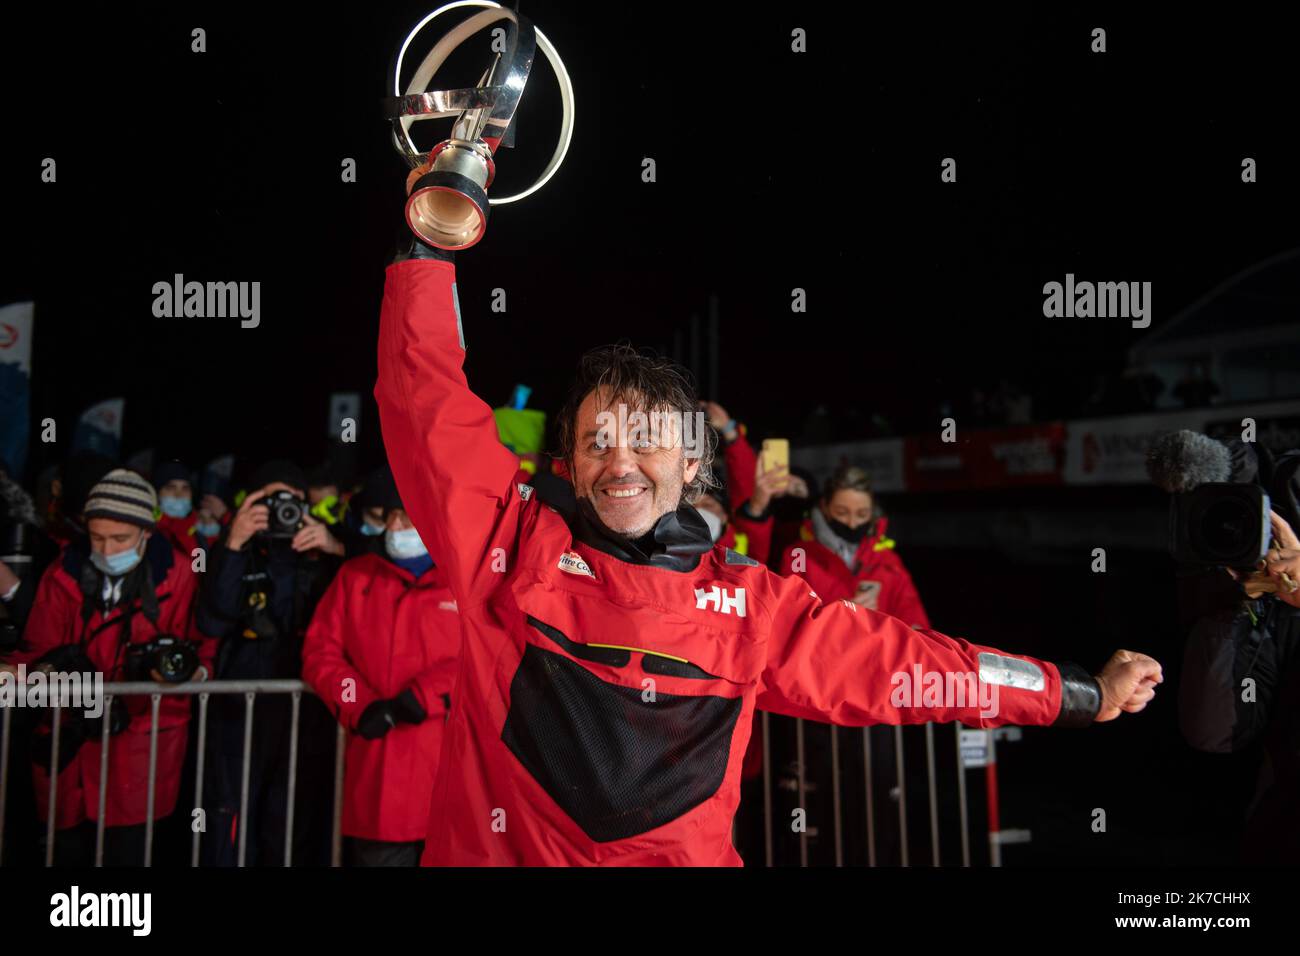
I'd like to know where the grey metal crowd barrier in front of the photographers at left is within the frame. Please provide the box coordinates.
[0,680,347,866]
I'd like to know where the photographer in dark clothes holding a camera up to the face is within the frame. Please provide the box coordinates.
[198,460,343,866]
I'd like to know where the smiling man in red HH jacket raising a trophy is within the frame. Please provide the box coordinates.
[376,179,1162,865]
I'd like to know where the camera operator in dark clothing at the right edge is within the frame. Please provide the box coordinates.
[1164,431,1300,865]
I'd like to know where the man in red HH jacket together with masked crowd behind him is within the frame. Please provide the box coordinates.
[0,175,1164,866]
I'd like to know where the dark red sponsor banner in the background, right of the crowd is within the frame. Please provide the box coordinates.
[906,421,1065,492]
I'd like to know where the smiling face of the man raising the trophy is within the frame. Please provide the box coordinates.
[571,390,699,538]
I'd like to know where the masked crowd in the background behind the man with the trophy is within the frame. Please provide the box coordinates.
[0,390,946,865]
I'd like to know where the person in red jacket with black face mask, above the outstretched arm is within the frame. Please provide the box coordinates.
[780,466,930,627]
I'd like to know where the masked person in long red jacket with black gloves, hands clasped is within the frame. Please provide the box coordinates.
[303,473,460,866]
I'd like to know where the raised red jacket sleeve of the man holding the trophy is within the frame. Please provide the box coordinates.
[374,251,520,606]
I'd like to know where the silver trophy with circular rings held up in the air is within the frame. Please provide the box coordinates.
[385,0,573,250]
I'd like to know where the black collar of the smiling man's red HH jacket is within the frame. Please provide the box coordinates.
[543,483,714,571]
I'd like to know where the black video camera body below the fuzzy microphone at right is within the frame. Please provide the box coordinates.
[1169,481,1273,571]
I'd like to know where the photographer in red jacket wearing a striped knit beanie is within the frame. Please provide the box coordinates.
[2,468,215,865]
